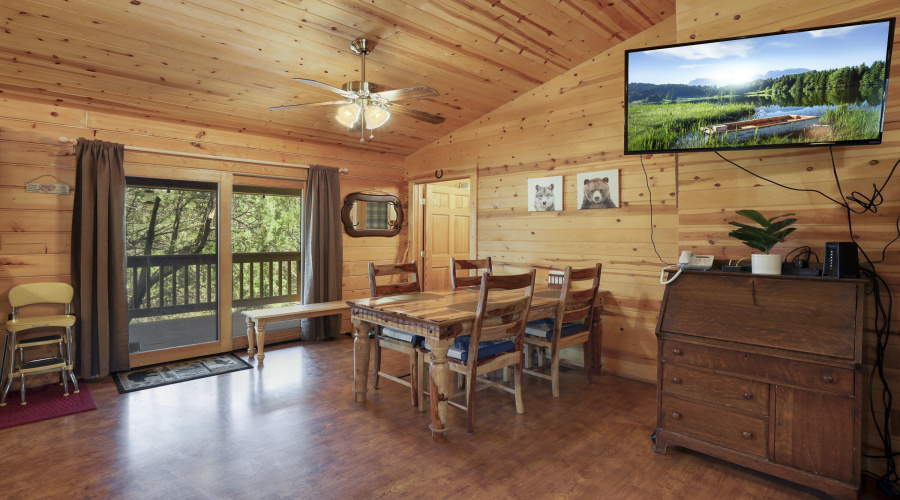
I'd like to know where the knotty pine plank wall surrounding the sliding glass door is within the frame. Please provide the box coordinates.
[0,98,407,372]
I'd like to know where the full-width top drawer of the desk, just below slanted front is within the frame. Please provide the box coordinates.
[662,340,855,396]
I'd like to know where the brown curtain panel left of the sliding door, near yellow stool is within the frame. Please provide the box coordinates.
[72,138,130,378]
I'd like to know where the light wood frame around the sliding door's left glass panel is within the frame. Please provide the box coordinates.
[123,162,234,368]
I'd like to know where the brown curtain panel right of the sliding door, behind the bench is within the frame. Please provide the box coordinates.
[300,165,344,340]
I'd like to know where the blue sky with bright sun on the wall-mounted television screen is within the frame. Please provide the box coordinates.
[628,22,889,85]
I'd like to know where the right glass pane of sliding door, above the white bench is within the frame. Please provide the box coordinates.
[231,186,303,337]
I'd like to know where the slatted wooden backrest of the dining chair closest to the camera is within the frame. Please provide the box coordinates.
[469,269,535,360]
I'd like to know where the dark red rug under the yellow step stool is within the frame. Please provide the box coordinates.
[0,381,97,429]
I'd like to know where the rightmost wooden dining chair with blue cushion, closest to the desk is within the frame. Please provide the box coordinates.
[525,264,603,397]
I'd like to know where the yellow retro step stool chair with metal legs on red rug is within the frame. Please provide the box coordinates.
[0,283,79,406]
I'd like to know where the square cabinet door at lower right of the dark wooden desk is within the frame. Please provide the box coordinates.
[775,387,860,484]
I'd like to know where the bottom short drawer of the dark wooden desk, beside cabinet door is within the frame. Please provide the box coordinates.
[659,396,769,457]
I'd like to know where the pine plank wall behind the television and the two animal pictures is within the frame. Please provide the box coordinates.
[407,0,900,471]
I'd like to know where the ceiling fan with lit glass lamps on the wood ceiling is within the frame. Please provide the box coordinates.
[269,38,444,142]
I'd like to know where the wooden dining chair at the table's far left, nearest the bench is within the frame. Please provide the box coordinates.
[369,261,425,406]
